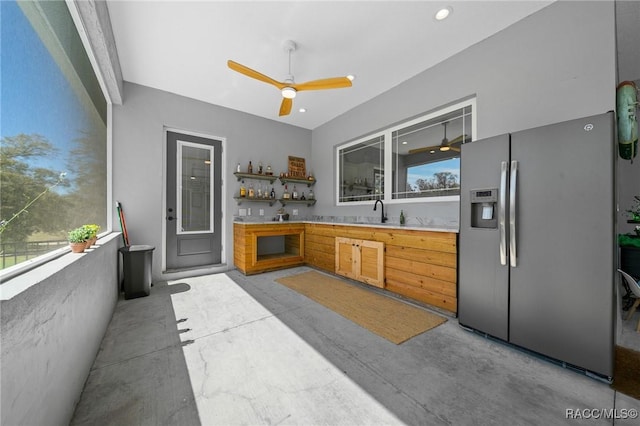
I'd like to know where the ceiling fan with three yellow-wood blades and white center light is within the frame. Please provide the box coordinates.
[227,40,351,116]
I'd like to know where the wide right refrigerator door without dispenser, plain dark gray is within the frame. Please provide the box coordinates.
[509,113,616,376]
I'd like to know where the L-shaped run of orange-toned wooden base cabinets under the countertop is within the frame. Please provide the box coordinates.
[238,222,458,313]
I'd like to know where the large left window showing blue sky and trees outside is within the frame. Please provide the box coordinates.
[0,1,108,269]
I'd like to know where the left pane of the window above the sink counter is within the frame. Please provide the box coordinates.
[338,135,385,203]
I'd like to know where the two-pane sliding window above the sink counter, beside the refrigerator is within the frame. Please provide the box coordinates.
[337,99,475,205]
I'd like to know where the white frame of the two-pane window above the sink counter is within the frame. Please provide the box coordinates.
[334,96,477,207]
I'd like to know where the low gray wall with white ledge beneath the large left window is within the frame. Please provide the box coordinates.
[0,234,121,425]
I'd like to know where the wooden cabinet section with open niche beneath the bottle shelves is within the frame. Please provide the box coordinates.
[233,222,304,275]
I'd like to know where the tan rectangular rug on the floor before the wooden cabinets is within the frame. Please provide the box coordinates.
[276,271,446,344]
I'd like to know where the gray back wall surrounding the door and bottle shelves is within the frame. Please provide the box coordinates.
[113,82,311,279]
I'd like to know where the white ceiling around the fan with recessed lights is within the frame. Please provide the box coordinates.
[108,0,553,129]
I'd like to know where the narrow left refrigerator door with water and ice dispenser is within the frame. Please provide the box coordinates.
[458,135,509,340]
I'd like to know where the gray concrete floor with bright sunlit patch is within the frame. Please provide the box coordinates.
[71,267,640,425]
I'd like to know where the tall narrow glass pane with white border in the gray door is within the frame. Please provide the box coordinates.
[176,141,213,234]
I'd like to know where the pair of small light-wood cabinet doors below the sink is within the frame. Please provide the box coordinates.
[335,237,384,288]
